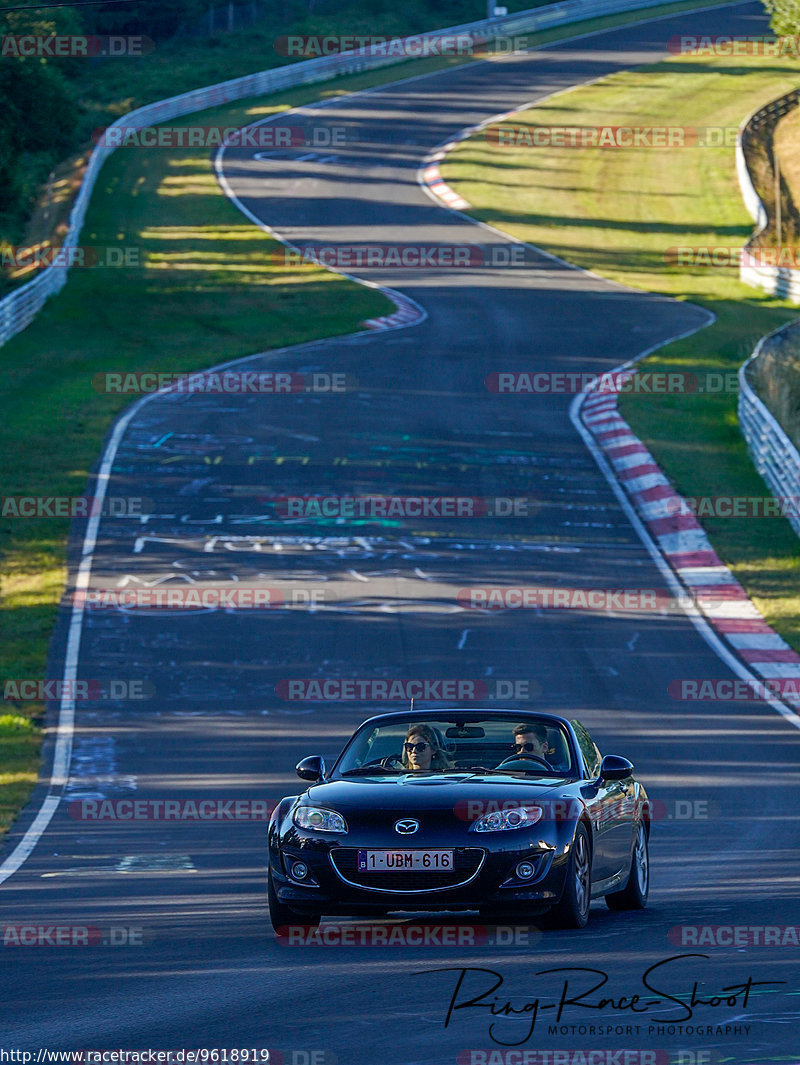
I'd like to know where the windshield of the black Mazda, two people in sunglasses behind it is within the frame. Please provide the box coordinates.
[337,715,574,776]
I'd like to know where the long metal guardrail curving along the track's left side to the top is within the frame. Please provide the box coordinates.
[0,0,711,344]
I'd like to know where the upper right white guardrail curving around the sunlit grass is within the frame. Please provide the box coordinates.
[736,88,800,304]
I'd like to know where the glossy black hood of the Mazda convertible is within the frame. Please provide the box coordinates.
[299,773,575,813]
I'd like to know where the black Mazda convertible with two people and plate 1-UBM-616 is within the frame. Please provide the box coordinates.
[267,709,650,934]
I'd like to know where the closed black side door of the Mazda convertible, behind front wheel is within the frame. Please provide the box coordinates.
[571,721,633,881]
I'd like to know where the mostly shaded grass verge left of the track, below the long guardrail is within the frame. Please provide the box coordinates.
[0,0,745,835]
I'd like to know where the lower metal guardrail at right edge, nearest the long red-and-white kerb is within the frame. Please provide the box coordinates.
[738,322,800,536]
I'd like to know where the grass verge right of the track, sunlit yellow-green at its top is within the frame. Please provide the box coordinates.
[441,47,800,651]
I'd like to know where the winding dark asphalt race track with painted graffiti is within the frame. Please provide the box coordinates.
[0,4,800,1065]
